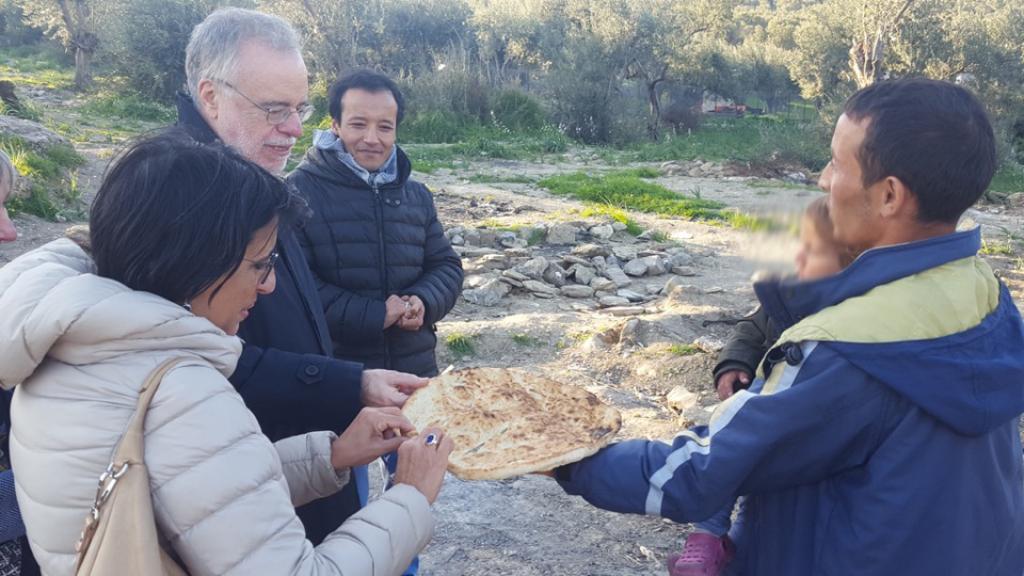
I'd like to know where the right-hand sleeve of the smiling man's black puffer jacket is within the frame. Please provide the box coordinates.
[403,193,463,326]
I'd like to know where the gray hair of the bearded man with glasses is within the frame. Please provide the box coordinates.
[185,8,302,98]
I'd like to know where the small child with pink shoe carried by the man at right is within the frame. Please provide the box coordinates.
[669,196,856,576]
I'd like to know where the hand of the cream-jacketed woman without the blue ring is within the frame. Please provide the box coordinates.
[331,408,416,469]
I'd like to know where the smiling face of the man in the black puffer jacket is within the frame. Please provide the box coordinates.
[331,88,398,172]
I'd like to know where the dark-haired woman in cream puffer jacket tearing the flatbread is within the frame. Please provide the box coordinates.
[0,133,452,575]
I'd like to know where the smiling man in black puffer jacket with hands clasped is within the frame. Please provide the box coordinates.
[289,72,463,376]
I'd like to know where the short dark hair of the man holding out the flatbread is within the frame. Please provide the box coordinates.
[844,79,996,222]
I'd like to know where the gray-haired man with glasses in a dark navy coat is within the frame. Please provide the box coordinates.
[178,8,425,544]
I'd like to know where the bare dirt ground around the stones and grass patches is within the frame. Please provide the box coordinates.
[0,115,1024,576]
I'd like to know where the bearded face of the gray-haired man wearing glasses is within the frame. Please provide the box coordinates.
[199,42,308,174]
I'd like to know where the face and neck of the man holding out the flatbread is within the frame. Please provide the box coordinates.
[818,114,885,251]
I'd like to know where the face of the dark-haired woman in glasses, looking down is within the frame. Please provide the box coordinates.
[191,220,278,335]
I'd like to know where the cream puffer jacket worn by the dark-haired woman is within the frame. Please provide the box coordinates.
[0,239,433,576]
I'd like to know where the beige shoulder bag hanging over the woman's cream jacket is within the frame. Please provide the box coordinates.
[75,358,187,576]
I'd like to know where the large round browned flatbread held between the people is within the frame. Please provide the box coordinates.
[402,368,622,480]
